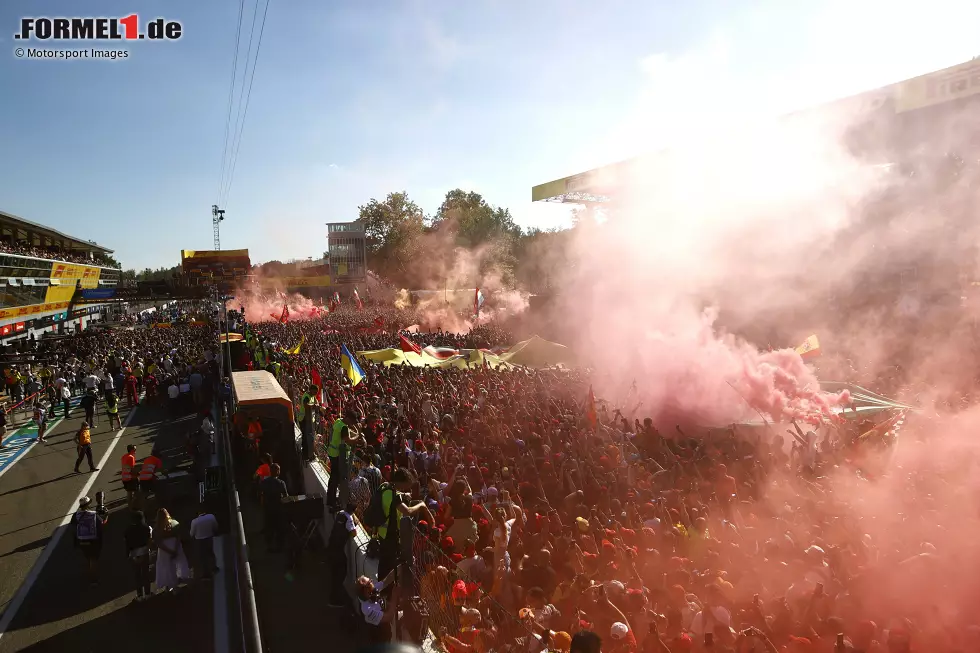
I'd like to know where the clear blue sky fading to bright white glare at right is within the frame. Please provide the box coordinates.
[0,0,980,268]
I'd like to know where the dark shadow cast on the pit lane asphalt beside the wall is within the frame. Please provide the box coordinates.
[0,407,213,653]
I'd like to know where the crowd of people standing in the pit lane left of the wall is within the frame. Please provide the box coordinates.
[3,316,219,601]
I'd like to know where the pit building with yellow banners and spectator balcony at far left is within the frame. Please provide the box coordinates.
[0,211,120,343]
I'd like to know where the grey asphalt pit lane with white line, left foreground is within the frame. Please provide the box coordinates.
[0,394,217,653]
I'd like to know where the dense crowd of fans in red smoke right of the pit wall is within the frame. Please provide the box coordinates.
[234,307,980,653]
